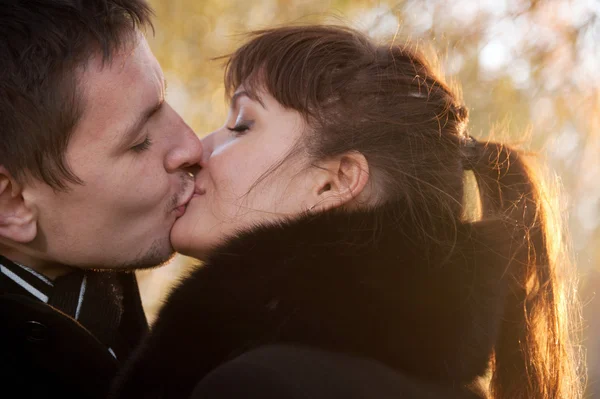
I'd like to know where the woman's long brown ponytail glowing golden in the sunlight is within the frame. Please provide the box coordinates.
[465,139,581,399]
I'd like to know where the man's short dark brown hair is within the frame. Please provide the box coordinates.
[0,0,152,189]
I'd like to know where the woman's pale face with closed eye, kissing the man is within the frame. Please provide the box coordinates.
[171,87,318,258]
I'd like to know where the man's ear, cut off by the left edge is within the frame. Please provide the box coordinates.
[0,165,37,244]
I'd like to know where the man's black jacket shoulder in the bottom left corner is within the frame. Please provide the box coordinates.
[0,291,118,397]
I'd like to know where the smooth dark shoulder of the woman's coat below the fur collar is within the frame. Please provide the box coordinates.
[192,345,478,399]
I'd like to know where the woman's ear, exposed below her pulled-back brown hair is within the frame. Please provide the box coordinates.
[310,151,369,210]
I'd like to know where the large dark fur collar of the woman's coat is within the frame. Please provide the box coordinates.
[116,203,508,398]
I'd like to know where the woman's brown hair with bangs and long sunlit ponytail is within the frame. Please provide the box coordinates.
[225,25,581,399]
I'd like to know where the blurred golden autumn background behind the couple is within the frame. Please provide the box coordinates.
[140,0,600,398]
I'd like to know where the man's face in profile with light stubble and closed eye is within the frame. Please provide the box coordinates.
[23,37,202,269]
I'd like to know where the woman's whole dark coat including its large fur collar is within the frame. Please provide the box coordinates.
[111,204,520,399]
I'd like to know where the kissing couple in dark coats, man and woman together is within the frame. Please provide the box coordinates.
[0,0,581,399]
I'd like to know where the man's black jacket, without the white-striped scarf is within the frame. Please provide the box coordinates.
[0,274,147,399]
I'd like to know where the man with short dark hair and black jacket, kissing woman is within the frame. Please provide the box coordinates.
[0,0,202,398]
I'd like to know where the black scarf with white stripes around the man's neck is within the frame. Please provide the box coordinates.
[0,255,147,358]
